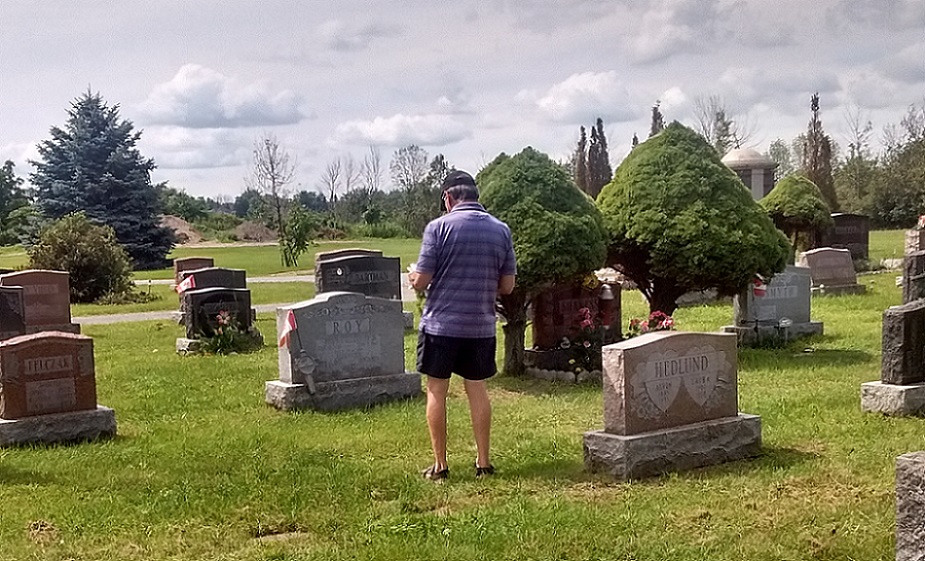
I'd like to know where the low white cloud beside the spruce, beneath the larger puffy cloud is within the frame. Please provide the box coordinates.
[139,127,253,169]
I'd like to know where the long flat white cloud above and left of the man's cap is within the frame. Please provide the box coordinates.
[333,113,470,146]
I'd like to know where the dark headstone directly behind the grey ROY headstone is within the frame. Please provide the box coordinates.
[315,254,402,300]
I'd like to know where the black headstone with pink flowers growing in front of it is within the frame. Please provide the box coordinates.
[183,287,253,339]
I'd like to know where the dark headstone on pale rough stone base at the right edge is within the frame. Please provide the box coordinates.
[861,300,925,415]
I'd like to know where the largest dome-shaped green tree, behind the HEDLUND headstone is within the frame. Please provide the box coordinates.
[597,122,790,314]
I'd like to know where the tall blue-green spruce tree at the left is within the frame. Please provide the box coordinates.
[30,91,174,269]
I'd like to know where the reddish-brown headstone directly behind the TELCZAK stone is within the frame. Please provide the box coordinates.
[0,270,80,333]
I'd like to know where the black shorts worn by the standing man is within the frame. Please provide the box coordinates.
[418,331,497,380]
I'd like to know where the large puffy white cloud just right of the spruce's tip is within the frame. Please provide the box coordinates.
[139,64,305,128]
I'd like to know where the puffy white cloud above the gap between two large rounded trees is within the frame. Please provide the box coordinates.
[517,71,639,124]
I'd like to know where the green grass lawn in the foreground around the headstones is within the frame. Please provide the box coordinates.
[0,273,908,561]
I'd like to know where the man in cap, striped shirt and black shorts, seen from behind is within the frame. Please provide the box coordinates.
[409,171,517,480]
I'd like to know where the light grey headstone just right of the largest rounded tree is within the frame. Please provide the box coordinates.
[723,265,823,345]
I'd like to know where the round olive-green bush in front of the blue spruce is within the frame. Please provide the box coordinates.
[29,212,132,302]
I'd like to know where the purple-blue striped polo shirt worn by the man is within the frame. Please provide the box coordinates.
[416,201,517,338]
